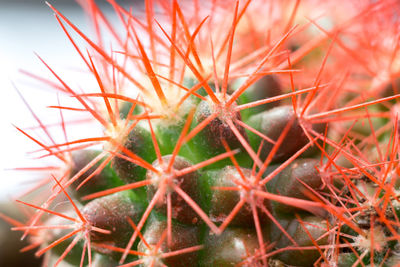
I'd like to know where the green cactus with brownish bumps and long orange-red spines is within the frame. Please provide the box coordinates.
[0,0,400,267]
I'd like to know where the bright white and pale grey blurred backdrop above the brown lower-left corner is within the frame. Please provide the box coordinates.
[0,0,88,201]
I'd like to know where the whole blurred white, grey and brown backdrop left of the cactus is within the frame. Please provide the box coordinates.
[0,0,138,267]
